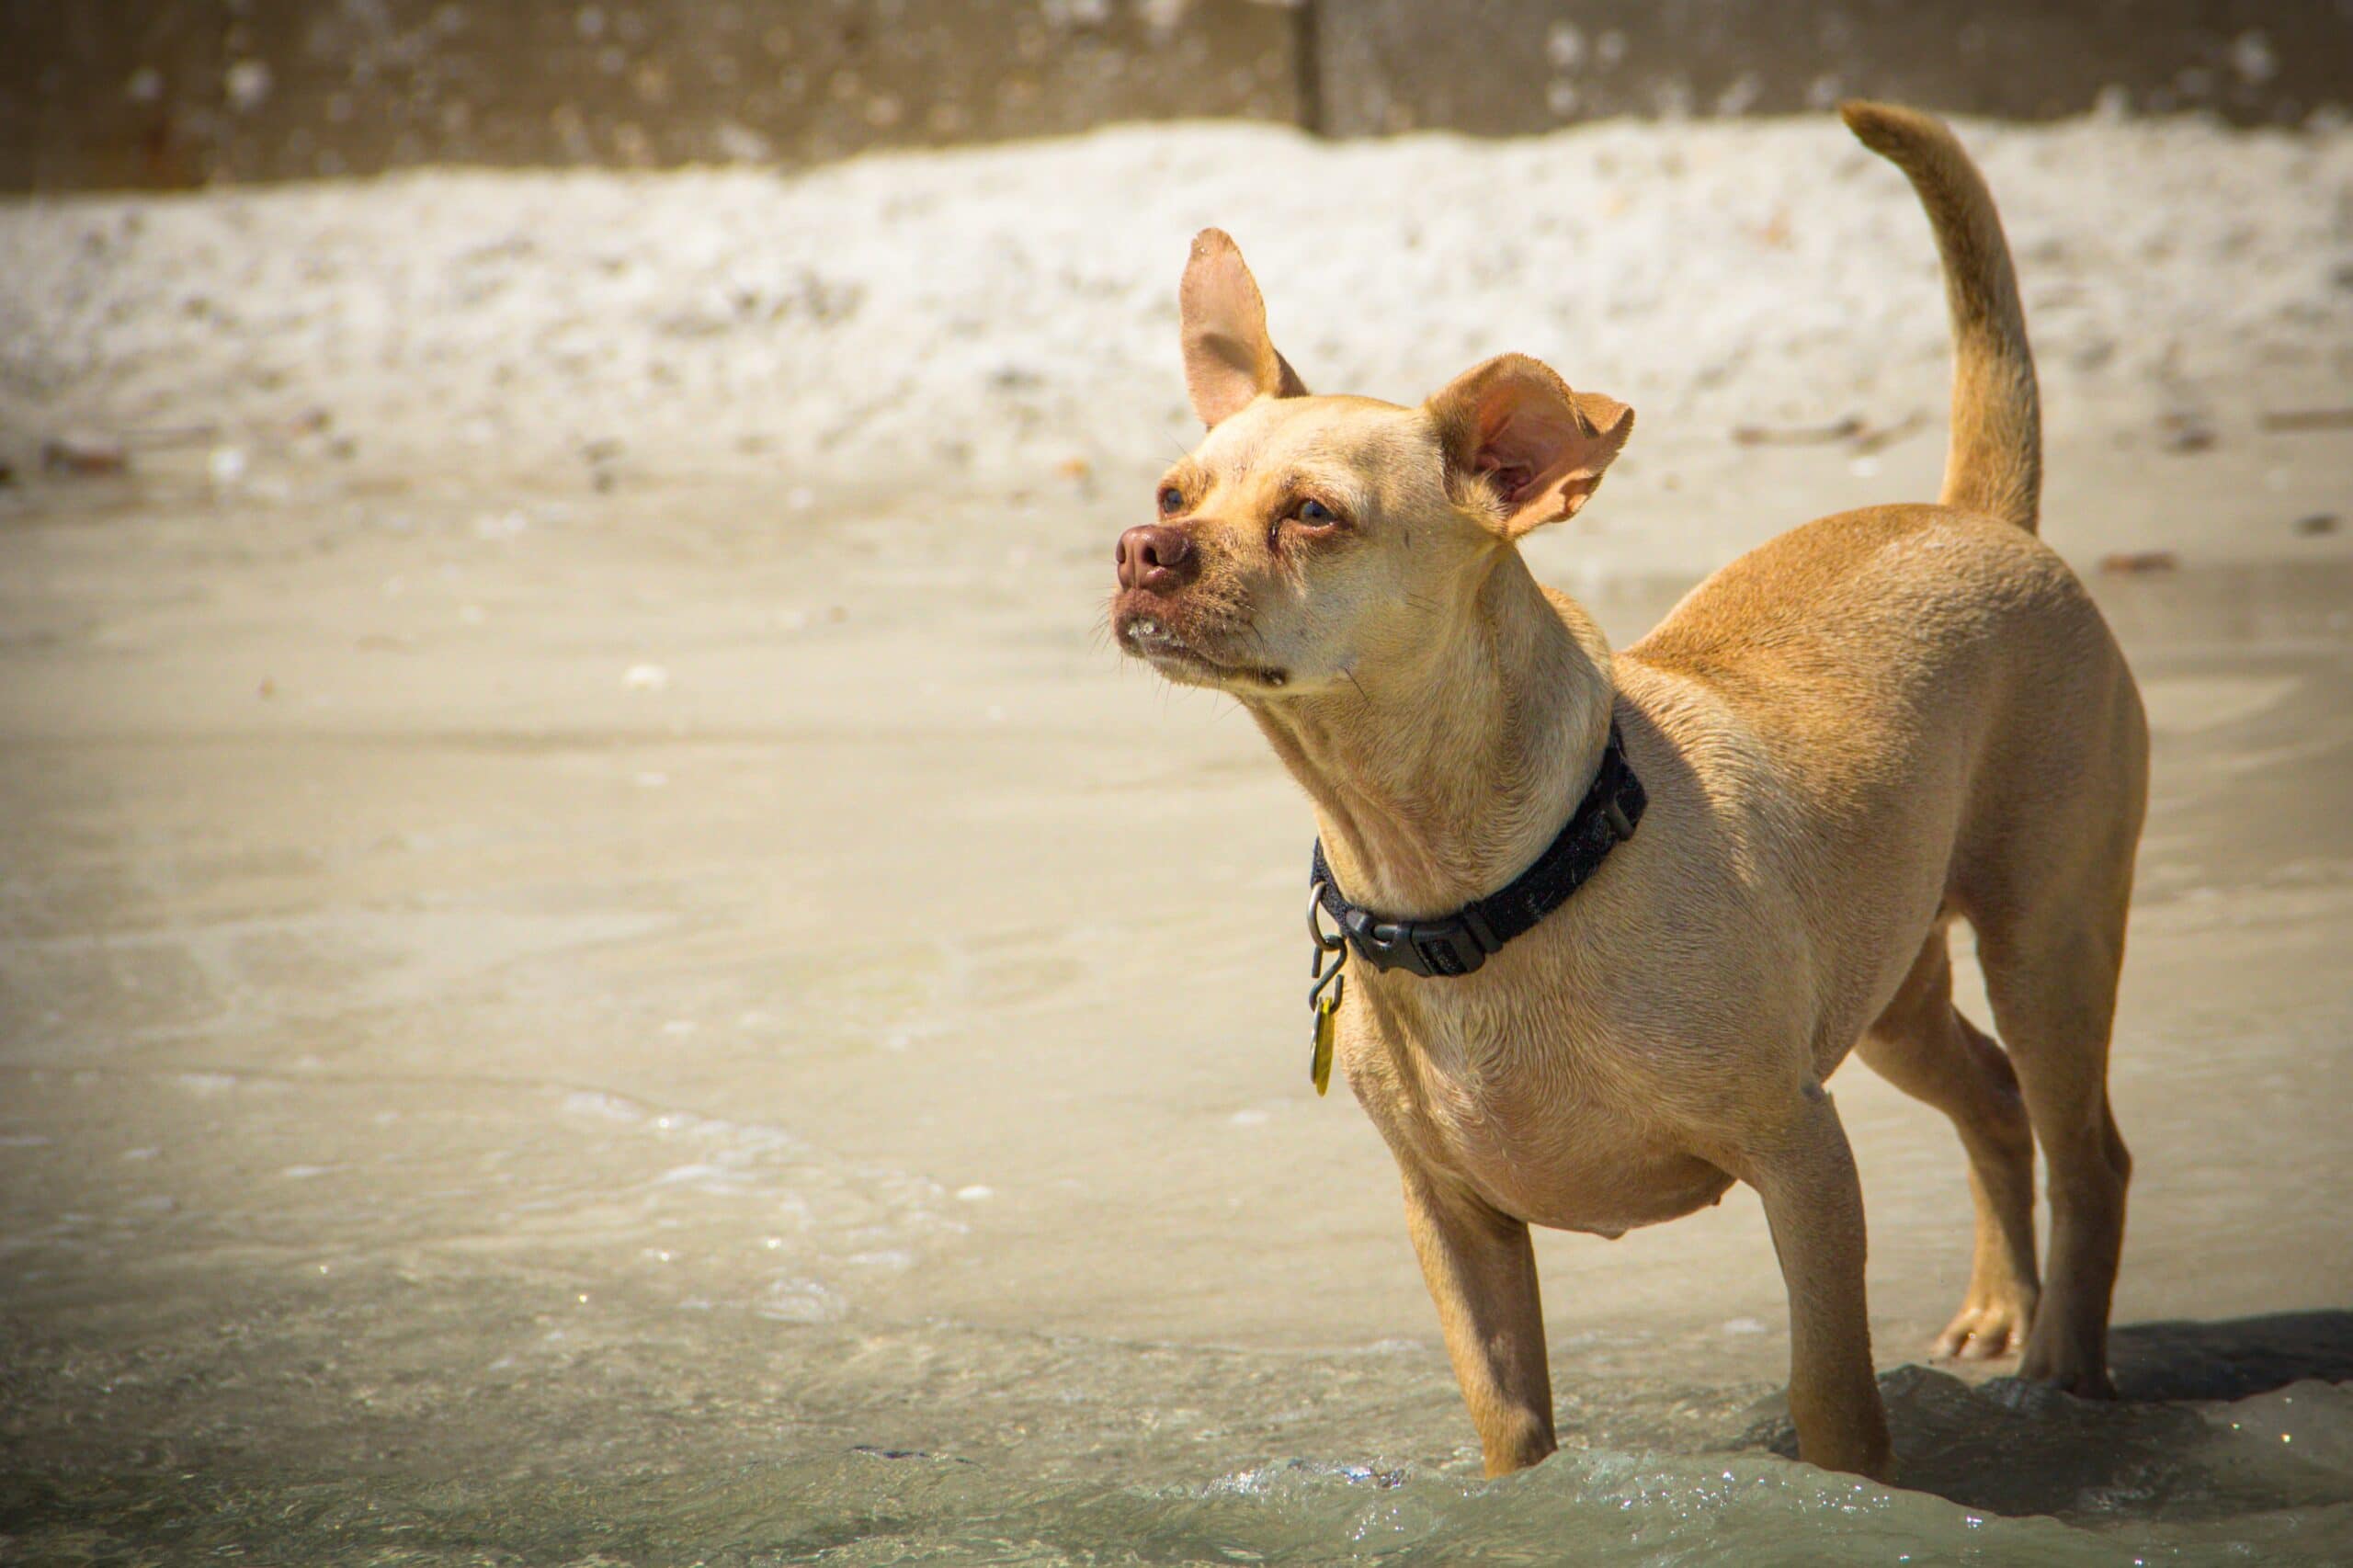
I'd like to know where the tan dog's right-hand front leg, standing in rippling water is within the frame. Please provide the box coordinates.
[1736,1085,1892,1481]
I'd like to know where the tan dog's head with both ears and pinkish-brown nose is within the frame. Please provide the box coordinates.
[1110,228,1633,701]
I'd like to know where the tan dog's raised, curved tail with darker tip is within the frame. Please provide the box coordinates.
[1837,101,2042,532]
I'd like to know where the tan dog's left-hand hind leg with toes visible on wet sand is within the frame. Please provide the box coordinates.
[1857,926,2038,1361]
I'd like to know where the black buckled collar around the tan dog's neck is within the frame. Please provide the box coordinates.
[1311,721,1647,977]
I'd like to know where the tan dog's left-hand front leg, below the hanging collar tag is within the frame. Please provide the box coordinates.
[1404,1170,1558,1476]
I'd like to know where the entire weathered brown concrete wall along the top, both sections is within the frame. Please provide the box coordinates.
[0,0,2353,190]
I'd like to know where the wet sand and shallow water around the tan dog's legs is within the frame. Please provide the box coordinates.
[0,480,2353,1563]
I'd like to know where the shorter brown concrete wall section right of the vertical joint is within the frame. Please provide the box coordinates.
[1320,0,2353,137]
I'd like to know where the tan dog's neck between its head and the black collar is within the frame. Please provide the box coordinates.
[1245,549,1614,918]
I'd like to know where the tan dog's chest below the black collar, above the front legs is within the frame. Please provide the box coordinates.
[1346,979,1732,1236]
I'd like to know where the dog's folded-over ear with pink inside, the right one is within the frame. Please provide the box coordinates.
[1428,353,1633,540]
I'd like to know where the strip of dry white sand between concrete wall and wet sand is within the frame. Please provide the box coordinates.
[0,118,2353,562]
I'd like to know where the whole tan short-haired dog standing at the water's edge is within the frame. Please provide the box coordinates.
[1113,104,2148,1476]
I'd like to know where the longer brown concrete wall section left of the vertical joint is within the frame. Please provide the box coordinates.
[0,0,1299,190]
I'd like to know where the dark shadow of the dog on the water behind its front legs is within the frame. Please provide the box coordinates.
[1748,1312,2353,1518]
